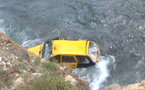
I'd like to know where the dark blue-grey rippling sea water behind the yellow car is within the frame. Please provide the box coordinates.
[0,0,145,87]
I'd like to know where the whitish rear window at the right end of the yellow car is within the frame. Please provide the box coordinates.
[89,42,99,58]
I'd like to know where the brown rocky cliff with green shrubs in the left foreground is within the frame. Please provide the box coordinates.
[0,33,89,90]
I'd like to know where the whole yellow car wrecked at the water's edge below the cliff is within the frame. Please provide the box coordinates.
[28,40,100,68]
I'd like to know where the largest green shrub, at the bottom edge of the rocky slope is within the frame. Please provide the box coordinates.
[18,73,76,90]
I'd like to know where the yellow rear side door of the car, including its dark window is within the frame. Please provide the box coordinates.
[60,55,77,68]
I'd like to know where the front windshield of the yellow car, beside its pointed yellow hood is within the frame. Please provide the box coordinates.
[43,42,52,59]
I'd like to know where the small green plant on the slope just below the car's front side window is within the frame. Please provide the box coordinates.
[42,62,57,71]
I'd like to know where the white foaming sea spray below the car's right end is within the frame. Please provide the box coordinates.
[74,55,115,90]
